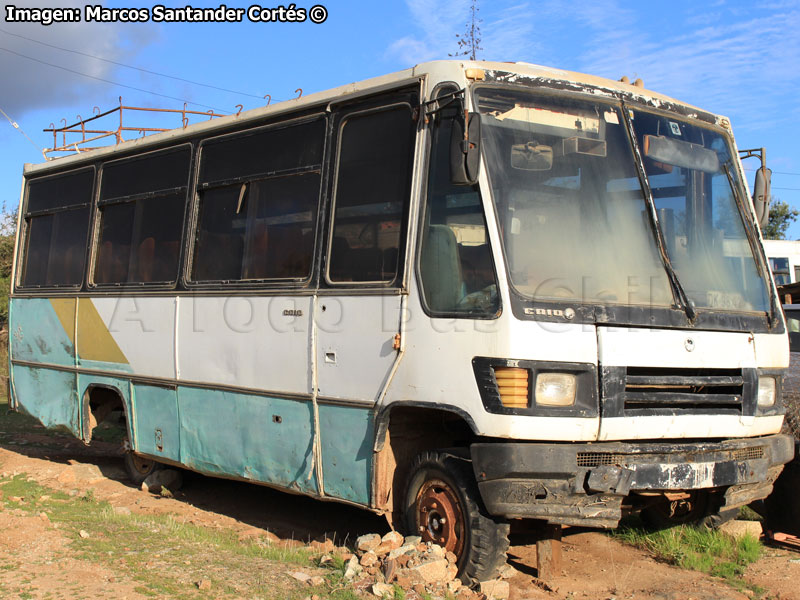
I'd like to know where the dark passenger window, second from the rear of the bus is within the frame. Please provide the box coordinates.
[93,146,191,285]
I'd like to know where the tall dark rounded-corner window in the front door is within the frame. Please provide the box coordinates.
[328,104,415,283]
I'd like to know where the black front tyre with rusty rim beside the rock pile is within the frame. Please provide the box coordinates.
[403,450,509,583]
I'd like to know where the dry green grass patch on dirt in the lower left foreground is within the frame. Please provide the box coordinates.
[0,475,357,600]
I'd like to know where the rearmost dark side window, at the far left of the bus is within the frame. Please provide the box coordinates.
[19,169,94,287]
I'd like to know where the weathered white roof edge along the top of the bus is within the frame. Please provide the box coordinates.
[24,60,724,176]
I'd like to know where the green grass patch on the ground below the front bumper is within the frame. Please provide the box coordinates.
[612,522,766,595]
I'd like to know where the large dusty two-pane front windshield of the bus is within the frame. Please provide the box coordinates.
[476,88,768,312]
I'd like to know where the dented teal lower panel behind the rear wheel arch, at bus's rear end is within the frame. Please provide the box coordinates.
[12,365,81,437]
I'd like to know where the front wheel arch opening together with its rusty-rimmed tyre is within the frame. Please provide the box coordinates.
[374,403,509,581]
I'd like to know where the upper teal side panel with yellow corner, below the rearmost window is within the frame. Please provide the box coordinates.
[10,298,75,368]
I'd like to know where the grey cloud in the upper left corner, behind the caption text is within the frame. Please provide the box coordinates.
[0,0,158,118]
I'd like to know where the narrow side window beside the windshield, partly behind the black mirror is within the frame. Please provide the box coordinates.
[419,110,500,316]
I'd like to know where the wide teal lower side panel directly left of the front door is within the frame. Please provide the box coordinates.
[178,387,317,494]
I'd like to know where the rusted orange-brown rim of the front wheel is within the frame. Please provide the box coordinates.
[416,479,465,557]
